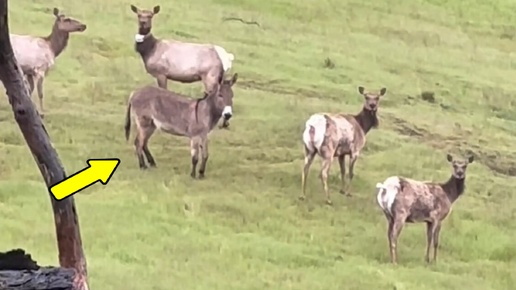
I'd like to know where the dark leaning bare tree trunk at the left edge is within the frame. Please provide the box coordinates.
[0,0,88,290]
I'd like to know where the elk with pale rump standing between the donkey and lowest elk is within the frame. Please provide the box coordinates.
[300,87,387,205]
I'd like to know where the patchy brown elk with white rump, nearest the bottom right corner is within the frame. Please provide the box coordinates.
[376,154,473,264]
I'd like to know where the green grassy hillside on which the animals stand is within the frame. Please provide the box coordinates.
[0,0,516,290]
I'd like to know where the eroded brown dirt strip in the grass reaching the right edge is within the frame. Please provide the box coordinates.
[389,116,516,176]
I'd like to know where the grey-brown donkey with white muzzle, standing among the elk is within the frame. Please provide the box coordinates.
[125,73,238,178]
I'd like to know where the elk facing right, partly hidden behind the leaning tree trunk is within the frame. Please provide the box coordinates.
[10,8,86,117]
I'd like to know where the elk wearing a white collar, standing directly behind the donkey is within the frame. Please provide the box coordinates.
[131,5,235,127]
